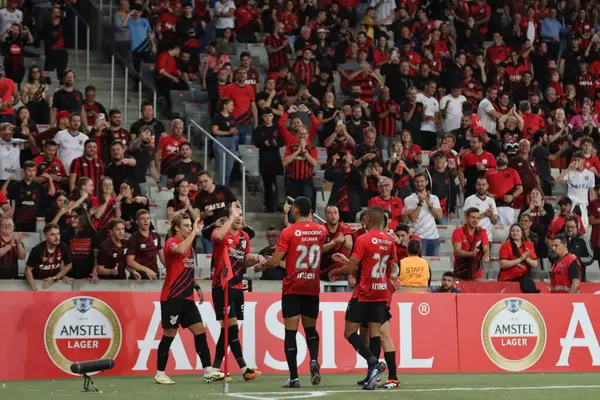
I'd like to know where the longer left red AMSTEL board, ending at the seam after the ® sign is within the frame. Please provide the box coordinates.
[0,292,459,380]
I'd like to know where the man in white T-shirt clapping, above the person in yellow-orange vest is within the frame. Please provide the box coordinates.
[402,172,443,257]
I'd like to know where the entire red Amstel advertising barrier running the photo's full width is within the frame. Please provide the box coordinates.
[0,292,600,380]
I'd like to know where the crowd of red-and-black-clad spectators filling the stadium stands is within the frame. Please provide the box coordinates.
[0,0,600,291]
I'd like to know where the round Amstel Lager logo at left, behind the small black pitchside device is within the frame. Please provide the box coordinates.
[44,297,122,374]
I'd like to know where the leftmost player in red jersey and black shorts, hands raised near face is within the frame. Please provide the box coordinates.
[154,214,224,385]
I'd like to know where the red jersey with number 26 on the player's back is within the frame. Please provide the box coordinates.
[352,230,396,302]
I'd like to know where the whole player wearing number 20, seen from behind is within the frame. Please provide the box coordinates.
[263,197,327,388]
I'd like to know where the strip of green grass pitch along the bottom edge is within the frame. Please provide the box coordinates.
[0,373,600,400]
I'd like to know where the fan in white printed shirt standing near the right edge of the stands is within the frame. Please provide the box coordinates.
[555,151,596,227]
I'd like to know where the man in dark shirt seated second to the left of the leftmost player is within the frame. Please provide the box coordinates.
[96,219,136,281]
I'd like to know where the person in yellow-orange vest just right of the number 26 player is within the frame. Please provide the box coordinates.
[399,239,431,293]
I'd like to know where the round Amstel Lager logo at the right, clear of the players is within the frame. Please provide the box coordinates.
[481,298,547,372]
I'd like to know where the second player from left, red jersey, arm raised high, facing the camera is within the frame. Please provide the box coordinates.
[212,202,264,381]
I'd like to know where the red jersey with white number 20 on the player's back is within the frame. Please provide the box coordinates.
[275,221,327,296]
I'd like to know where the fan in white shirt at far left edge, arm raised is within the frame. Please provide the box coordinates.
[0,122,35,181]
